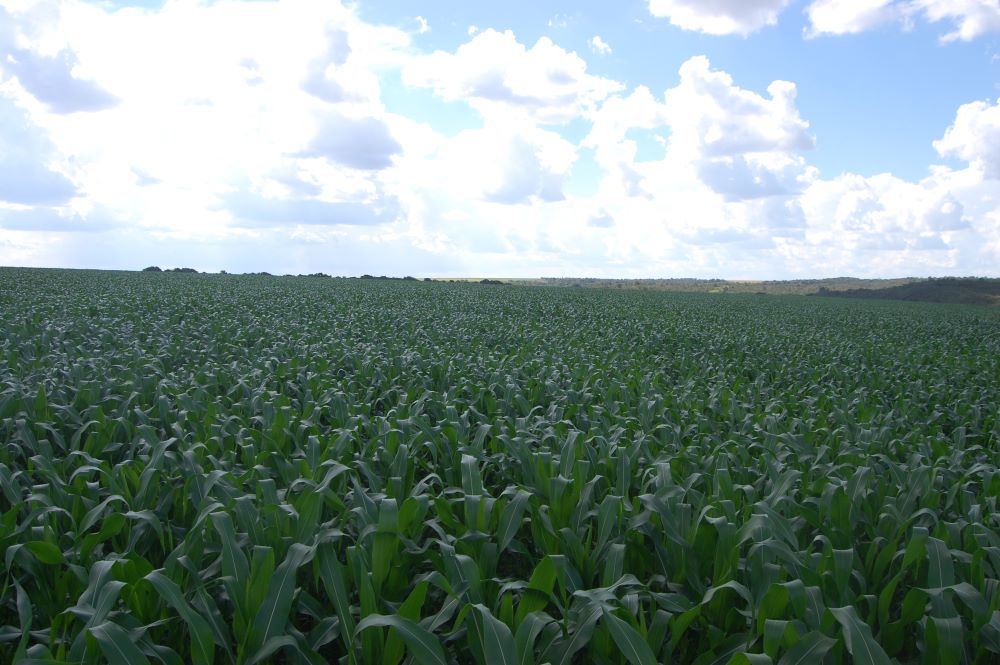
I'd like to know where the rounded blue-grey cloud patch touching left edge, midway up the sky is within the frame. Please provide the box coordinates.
[0,95,77,205]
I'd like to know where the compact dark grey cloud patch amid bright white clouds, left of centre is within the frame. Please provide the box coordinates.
[301,112,402,171]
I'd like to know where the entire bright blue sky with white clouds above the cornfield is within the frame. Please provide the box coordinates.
[0,0,1000,279]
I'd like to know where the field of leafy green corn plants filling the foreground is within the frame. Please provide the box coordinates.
[0,269,1000,665]
